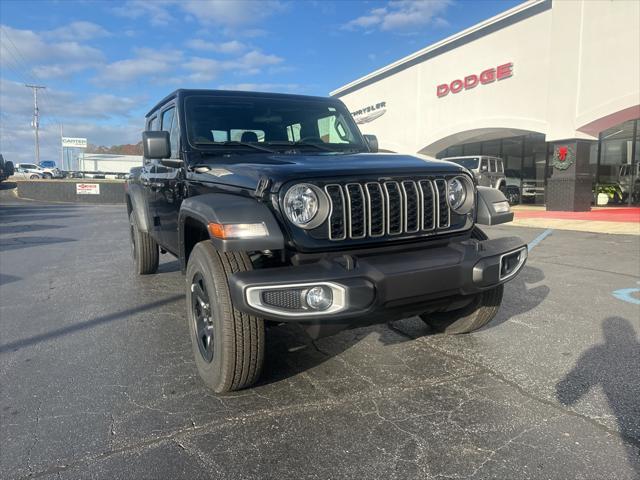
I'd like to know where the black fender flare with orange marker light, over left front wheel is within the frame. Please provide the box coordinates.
[178,193,285,264]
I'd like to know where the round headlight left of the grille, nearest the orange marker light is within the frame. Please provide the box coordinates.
[283,183,327,228]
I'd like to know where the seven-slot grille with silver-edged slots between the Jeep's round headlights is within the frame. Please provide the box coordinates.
[324,178,451,240]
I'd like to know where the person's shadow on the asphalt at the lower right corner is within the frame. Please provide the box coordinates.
[556,317,640,477]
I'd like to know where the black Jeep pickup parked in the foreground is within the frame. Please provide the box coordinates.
[126,90,527,393]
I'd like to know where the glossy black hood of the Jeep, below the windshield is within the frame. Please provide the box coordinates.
[190,153,466,190]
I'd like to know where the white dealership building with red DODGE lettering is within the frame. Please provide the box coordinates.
[331,0,640,210]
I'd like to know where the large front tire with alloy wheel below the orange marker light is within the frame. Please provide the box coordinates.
[186,240,265,393]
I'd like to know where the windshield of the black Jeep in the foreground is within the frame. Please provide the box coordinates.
[185,96,368,153]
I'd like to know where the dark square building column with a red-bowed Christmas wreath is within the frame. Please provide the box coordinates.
[546,139,593,212]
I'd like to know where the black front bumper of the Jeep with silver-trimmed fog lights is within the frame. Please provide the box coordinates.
[229,237,527,323]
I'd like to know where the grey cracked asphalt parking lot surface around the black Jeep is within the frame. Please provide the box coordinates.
[0,193,640,480]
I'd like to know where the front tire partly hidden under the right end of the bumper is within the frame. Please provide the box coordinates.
[420,285,504,335]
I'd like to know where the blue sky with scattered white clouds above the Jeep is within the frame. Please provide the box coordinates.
[0,0,520,162]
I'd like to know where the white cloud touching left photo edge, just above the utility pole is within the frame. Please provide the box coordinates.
[0,25,104,78]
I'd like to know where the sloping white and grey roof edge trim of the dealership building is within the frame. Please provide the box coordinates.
[330,0,552,98]
